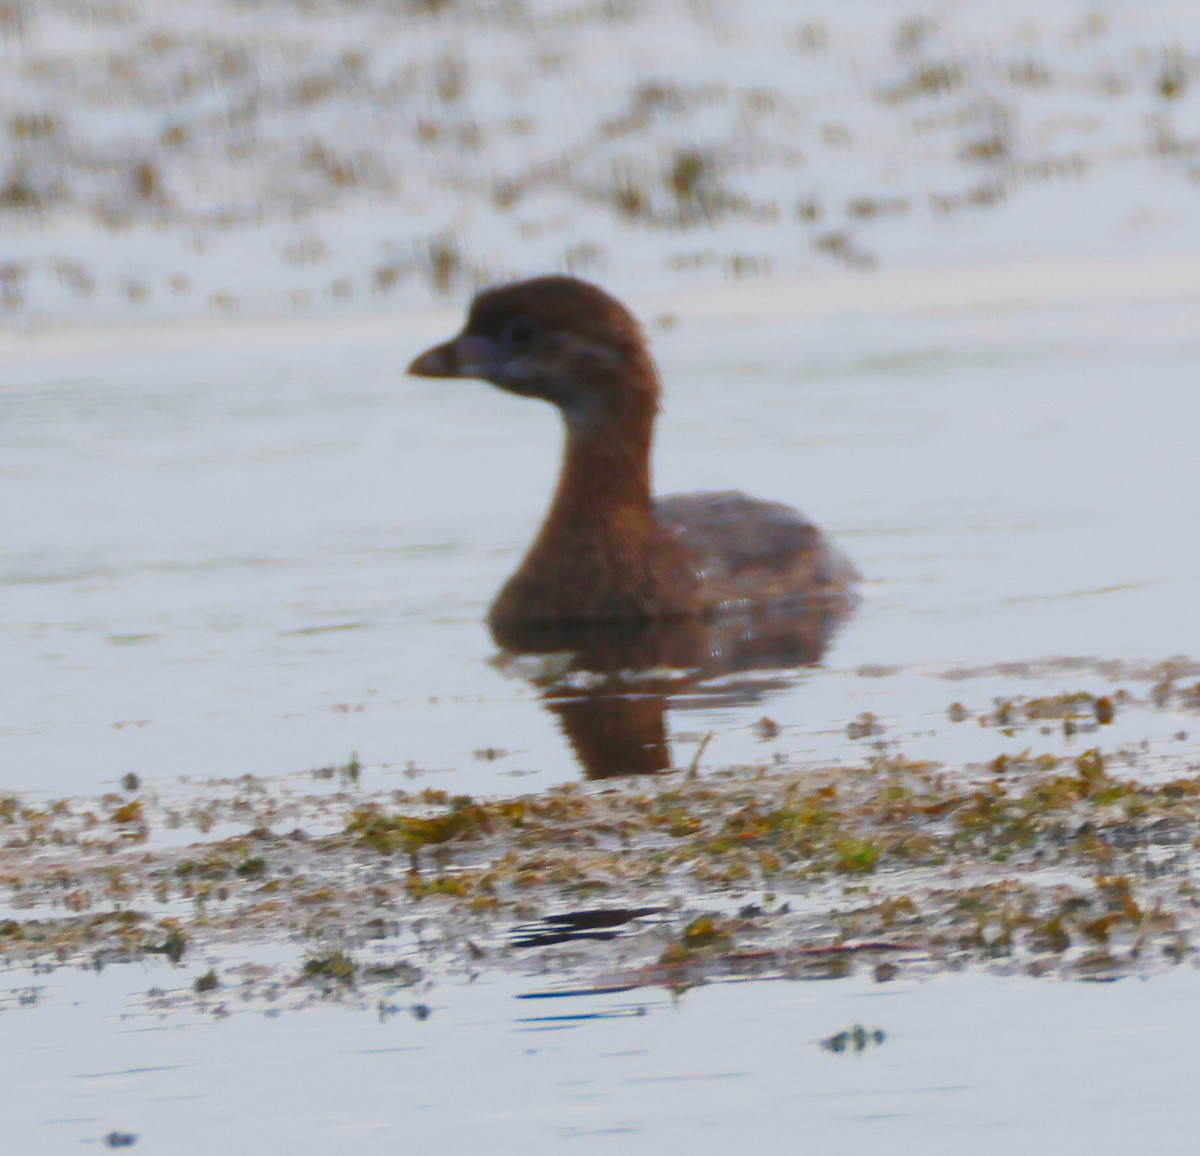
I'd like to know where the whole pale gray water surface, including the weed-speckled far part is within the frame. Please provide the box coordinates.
[7,0,1200,1142]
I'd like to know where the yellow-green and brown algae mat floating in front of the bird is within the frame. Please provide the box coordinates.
[0,720,1200,993]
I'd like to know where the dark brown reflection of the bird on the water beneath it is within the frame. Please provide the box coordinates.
[492,597,856,779]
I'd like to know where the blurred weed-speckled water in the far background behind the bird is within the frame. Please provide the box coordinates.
[0,0,1200,324]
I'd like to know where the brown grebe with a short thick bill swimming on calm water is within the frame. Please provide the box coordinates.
[408,276,858,631]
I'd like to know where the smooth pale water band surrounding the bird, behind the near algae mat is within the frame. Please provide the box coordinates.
[0,259,1200,795]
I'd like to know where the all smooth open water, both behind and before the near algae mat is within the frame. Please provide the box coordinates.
[0,264,1200,1154]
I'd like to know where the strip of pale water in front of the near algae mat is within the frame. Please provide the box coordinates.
[7,968,1200,1154]
